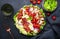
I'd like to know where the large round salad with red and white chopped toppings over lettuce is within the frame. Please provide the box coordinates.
[13,5,46,36]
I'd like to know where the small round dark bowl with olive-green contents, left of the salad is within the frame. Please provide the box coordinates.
[1,3,14,16]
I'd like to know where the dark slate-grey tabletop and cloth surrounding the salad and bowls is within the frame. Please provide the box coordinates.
[0,0,60,39]
